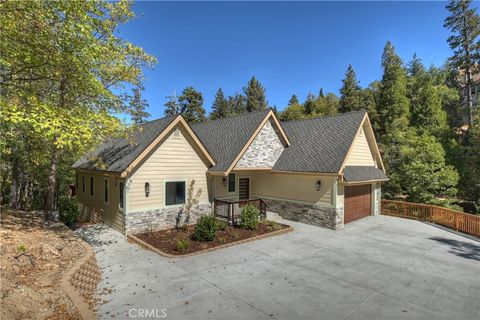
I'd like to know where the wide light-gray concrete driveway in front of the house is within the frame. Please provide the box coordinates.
[82,216,480,320]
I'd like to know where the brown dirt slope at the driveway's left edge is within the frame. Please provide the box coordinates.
[0,208,85,320]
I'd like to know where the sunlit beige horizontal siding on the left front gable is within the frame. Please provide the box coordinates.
[127,128,208,212]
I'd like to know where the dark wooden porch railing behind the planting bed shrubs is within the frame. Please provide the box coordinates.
[213,199,267,224]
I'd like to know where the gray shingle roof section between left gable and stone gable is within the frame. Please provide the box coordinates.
[191,110,270,172]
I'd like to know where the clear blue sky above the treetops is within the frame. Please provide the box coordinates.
[118,1,458,119]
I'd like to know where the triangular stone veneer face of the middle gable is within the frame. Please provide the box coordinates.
[236,120,284,168]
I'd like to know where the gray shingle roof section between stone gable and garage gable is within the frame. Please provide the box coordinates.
[273,111,366,173]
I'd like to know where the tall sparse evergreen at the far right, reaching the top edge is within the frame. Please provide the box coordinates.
[444,0,480,125]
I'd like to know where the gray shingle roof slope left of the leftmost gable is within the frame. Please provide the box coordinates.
[73,116,176,172]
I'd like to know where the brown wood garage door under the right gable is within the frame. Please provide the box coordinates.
[344,184,372,223]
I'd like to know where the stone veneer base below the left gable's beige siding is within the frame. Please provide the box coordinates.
[125,204,212,234]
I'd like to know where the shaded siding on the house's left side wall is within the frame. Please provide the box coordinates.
[77,172,125,233]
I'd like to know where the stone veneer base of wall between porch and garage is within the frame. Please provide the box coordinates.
[262,198,343,230]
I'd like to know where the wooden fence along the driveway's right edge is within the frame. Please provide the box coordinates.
[382,200,480,237]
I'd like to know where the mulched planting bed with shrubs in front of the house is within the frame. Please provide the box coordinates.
[135,220,290,256]
